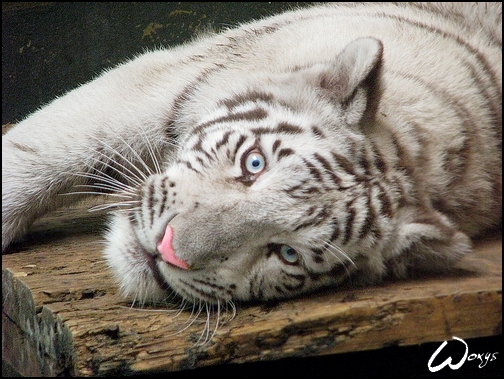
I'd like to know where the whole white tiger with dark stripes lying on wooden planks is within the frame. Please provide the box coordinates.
[2,3,502,304]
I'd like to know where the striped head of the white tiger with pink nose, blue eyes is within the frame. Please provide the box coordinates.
[106,38,384,303]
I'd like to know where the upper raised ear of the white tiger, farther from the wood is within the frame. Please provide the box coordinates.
[318,37,383,125]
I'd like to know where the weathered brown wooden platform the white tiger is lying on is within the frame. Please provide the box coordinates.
[2,199,502,376]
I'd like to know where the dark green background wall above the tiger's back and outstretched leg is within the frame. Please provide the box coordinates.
[2,2,309,124]
